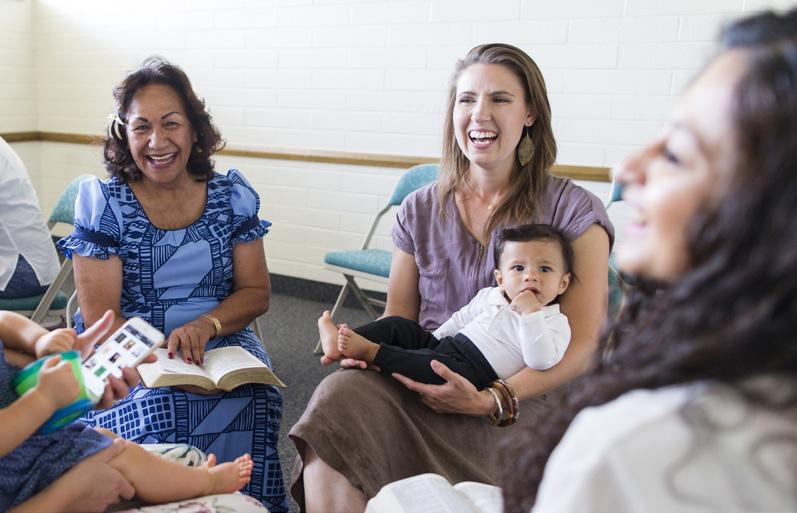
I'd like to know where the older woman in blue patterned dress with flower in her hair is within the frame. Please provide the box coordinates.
[59,57,288,512]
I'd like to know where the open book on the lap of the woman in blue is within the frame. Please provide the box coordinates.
[138,346,285,392]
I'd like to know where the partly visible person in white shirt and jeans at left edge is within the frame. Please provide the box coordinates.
[0,138,59,299]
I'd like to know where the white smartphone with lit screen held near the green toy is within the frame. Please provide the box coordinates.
[81,317,166,398]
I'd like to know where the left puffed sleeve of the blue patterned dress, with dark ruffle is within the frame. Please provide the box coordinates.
[57,178,124,260]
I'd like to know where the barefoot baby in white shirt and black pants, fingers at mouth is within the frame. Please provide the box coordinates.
[318,224,573,390]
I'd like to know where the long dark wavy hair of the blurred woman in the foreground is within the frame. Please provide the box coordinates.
[500,10,797,513]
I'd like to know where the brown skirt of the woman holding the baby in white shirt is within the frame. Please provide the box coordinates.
[288,369,559,511]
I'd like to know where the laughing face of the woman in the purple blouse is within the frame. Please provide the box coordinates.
[453,64,535,175]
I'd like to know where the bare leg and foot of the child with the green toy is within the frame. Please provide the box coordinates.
[99,430,252,503]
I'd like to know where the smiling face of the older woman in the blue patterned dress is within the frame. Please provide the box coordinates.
[125,84,196,184]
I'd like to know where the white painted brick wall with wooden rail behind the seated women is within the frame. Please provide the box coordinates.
[0,0,795,288]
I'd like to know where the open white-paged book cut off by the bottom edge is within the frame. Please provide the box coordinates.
[365,474,504,513]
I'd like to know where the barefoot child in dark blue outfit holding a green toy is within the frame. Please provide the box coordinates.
[0,311,252,511]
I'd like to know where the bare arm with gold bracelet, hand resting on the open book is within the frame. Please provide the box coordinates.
[167,239,271,362]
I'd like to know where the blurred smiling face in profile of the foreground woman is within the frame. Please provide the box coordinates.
[615,52,744,282]
